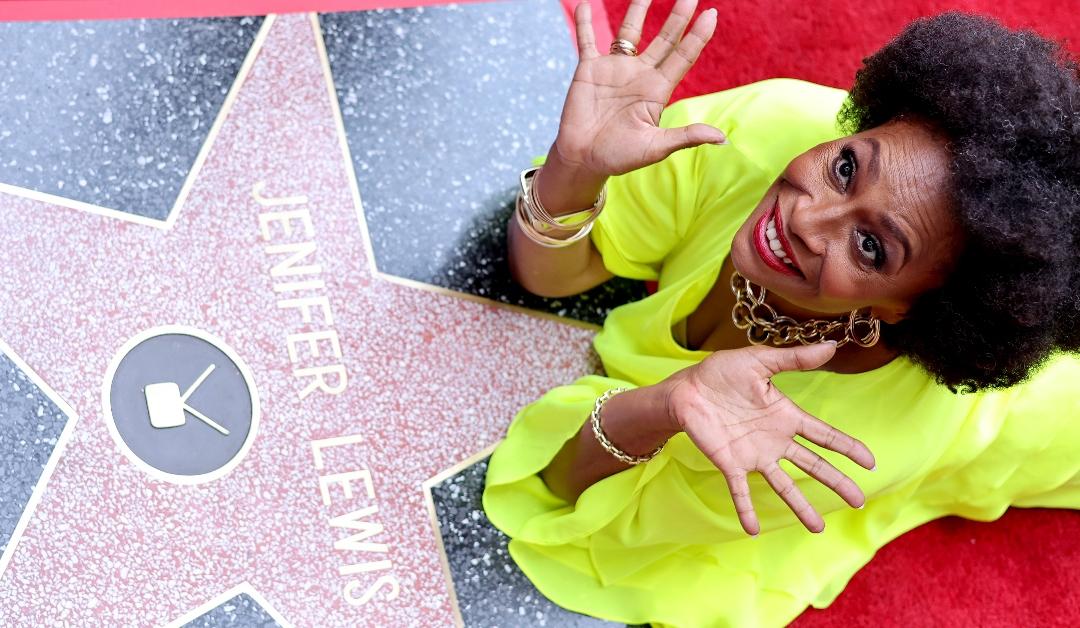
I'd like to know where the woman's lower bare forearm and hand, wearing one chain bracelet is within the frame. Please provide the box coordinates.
[540,343,874,534]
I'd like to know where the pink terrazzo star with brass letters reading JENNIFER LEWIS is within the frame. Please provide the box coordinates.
[0,15,592,626]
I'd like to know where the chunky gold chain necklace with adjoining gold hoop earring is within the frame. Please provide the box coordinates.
[731,271,881,347]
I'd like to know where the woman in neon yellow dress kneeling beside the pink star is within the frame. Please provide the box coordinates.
[484,0,1080,626]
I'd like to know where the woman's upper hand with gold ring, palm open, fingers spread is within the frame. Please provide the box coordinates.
[555,0,726,176]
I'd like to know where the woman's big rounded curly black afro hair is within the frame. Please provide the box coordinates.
[839,13,1080,391]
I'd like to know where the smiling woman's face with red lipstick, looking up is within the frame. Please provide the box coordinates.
[731,120,963,322]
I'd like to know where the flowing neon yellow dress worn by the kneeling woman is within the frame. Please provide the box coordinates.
[484,80,1080,628]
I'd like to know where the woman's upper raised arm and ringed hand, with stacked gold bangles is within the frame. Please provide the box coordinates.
[507,0,726,296]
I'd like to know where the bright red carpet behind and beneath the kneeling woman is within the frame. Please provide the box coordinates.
[604,0,1080,628]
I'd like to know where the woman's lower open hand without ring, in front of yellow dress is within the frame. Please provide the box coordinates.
[669,343,875,534]
